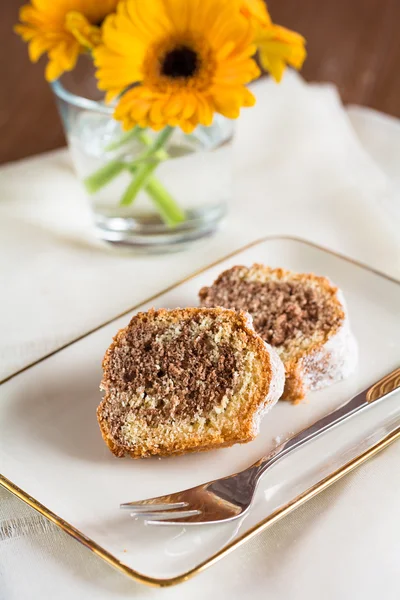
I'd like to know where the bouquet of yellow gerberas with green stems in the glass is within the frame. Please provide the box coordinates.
[15,0,306,246]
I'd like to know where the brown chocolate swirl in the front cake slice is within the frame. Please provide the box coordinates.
[101,315,241,435]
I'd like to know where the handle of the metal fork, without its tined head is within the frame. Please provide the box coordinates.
[251,367,400,479]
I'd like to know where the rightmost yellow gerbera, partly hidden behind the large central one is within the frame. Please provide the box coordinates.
[240,0,307,83]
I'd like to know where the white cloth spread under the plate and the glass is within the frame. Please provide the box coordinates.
[0,73,400,600]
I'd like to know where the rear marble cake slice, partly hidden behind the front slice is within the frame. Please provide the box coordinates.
[199,264,357,402]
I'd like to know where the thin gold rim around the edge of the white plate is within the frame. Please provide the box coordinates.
[0,236,400,587]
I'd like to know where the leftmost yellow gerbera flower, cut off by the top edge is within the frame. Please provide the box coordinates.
[15,0,118,81]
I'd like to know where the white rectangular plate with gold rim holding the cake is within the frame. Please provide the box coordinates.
[0,238,400,585]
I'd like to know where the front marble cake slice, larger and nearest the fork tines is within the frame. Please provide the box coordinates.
[97,308,284,458]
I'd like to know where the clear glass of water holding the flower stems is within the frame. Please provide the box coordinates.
[52,64,233,251]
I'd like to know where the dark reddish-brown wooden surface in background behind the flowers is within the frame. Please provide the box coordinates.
[0,0,400,163]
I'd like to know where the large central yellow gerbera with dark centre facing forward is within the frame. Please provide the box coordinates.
[94,0,259,132]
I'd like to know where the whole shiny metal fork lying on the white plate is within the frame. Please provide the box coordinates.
[120,368,400,525]
